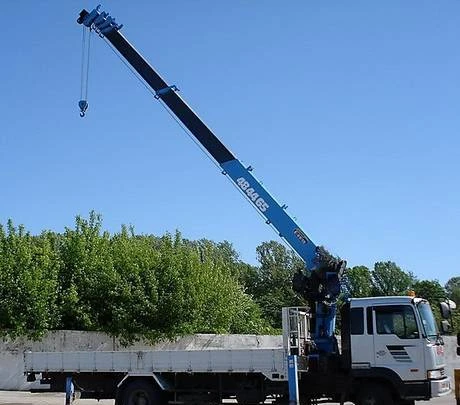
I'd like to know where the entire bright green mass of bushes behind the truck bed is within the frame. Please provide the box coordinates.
[0,212,271,342]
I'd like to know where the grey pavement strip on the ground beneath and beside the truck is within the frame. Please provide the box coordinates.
[0,391,455,405]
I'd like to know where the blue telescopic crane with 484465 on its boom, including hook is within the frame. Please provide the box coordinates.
[77,6,346,353]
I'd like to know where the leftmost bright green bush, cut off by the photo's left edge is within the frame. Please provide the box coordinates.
[0,220,59,337]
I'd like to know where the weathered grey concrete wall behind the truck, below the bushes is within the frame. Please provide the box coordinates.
[0,331,460,390]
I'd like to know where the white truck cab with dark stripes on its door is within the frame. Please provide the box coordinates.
[342,296,451,400]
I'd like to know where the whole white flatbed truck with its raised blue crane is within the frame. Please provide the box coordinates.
[24,6,451,405]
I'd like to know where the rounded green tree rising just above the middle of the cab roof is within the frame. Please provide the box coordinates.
[372,261,415,296]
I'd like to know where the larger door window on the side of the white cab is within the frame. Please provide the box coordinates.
[374,305,419,339]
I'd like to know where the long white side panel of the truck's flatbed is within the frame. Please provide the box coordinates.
[24,348,287,381]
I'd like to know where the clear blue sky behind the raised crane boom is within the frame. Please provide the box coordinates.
[0,0,460,284]
